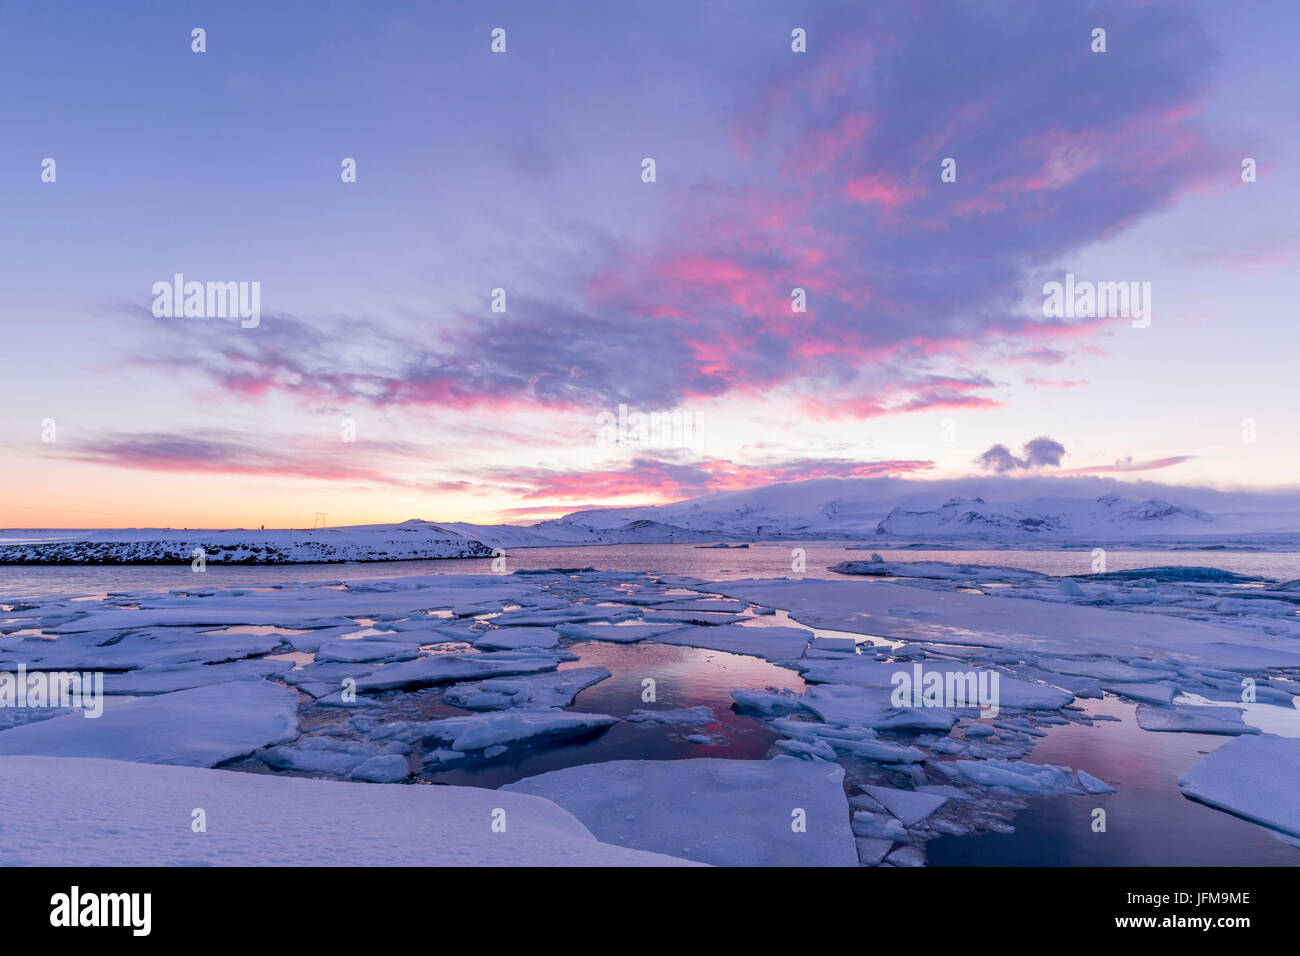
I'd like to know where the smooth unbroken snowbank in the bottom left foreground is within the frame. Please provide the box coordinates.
[0,757,692,866]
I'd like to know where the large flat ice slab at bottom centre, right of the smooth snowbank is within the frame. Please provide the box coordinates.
[498,757,858,866]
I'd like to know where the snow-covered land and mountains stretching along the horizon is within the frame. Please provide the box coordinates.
[10,477,1300,564]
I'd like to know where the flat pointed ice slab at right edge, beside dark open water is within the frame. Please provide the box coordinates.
[1178,735,1300,838]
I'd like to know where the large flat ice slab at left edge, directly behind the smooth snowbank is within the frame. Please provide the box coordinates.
[0,680,298,766]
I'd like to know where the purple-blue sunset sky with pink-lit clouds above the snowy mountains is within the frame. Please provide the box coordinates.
[0,0,1300,528]
